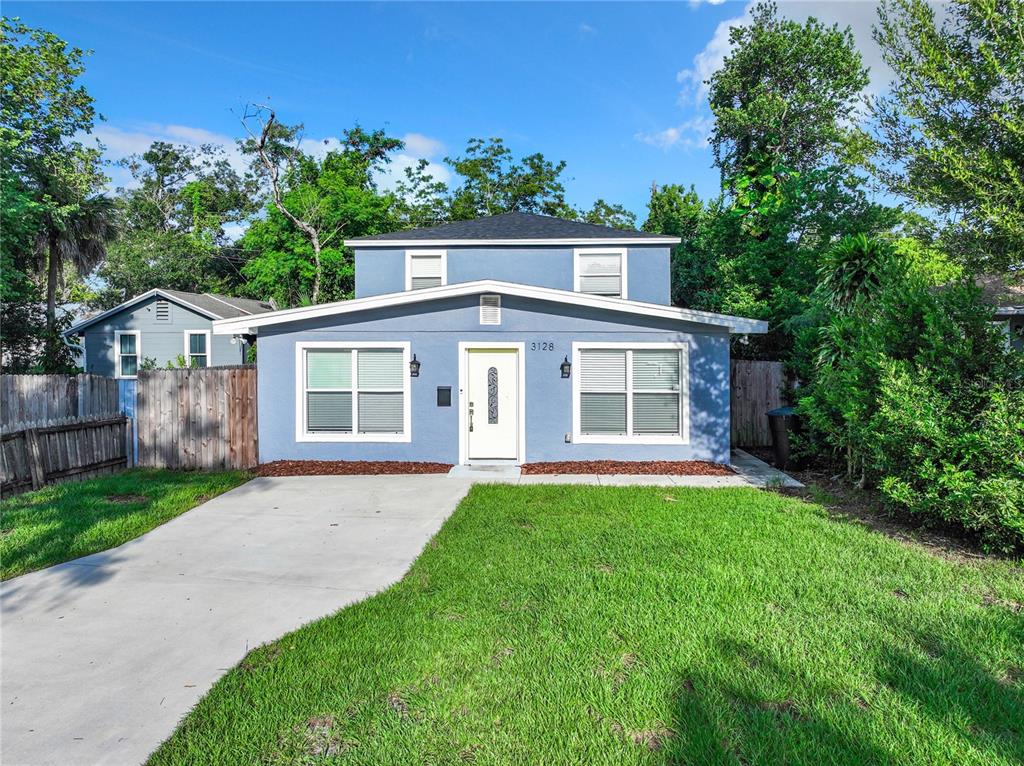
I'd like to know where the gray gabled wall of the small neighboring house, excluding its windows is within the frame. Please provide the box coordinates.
[84,296,244,378]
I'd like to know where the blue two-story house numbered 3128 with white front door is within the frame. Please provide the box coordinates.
[213,213,767,464]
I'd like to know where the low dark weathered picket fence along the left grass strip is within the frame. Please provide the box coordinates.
[0,415,131,495]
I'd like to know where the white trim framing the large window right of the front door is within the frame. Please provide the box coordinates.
[571,341,690,444]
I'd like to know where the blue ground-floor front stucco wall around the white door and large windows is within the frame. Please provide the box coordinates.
[257,296,729,463]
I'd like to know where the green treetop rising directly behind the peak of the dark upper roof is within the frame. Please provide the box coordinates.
[444,138,575,220]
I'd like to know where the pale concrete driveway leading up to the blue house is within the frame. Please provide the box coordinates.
[0,476,471,766]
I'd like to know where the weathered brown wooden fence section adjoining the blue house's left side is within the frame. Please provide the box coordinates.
[135,366,259,468]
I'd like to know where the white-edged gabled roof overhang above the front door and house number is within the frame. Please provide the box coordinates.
[213,280,768,335]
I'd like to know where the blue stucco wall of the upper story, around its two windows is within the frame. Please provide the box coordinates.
[355,247,671,304]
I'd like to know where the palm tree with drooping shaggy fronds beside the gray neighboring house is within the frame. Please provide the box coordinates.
[36,195,117,358]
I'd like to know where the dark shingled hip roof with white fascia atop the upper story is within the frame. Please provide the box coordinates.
[346,213,677,244]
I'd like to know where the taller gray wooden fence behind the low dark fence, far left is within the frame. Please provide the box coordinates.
[0,375,121,425]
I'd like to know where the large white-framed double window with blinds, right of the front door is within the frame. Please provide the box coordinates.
[573,343,688,443]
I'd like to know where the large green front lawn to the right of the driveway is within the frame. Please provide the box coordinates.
[152,485,1024,766]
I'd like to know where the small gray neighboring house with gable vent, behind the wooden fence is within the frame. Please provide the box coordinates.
[65,289,273,379]
